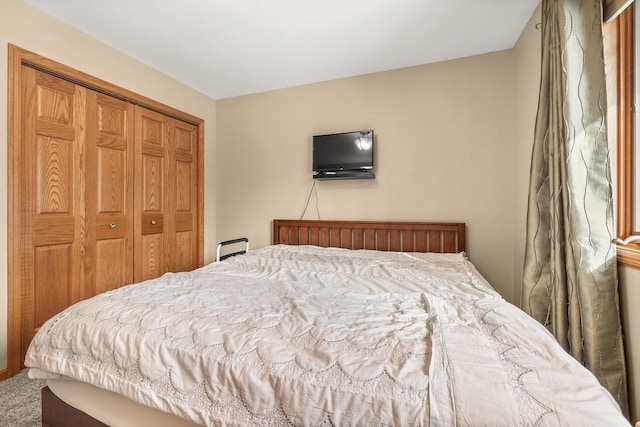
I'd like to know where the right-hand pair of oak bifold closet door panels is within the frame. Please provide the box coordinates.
[134,106,198,282]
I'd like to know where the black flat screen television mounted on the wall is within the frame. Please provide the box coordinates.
[313,130,374,178]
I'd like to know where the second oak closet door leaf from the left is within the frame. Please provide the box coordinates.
[85,91,134,297]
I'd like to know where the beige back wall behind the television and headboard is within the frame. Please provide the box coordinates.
[216,51,514,300]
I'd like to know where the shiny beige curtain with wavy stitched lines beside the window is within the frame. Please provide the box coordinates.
[522,0,628,414]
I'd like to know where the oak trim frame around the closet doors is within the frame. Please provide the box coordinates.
[6,44,204,379]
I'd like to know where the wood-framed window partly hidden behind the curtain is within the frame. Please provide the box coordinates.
[604,6,640,268]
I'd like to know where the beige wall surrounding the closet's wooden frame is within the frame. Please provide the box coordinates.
[0,0,216,370]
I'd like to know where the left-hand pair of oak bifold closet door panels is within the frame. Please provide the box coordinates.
[19,67,134,362]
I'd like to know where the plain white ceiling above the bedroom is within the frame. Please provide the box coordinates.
[24,0,539,99]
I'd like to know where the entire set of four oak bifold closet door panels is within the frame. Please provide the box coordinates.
[8,45,203,375]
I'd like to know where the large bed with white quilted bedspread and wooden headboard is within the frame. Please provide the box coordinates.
[25,220,629,427]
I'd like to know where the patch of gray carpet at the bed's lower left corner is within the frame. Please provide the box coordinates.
[0,369,44,427]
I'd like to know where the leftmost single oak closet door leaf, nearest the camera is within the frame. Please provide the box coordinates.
[17,66,86,357]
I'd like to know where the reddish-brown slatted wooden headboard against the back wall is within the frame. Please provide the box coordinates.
[272,219,465,253]
